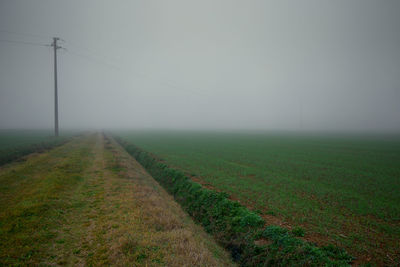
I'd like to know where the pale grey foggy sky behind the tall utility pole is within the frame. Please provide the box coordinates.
[0,0,400,132]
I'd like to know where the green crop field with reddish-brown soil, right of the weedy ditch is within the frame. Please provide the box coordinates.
[118,131,400,265]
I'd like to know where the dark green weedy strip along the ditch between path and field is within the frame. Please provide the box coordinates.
[114,136,353,266]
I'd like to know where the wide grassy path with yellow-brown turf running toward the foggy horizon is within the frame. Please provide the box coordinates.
[0,134,232,266]
